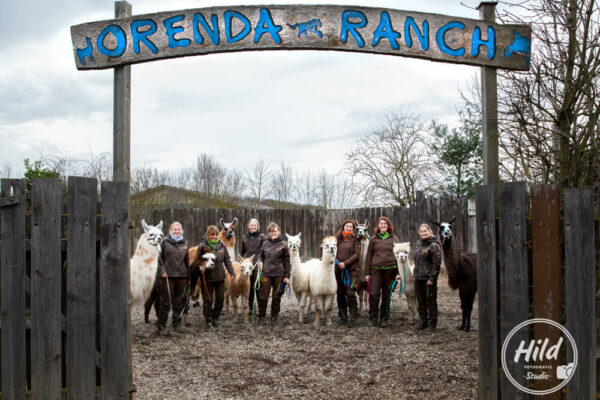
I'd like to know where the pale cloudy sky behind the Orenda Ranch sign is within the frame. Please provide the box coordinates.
[0,0,486,178]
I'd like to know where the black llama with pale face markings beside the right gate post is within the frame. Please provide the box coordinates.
[432,217,477,332]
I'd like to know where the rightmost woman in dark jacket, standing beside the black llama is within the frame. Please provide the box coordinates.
[413,224,442,332]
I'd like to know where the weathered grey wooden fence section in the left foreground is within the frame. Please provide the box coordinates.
[0,177,131,400]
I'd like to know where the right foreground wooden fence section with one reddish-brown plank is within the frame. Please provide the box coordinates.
[476,183,598,400]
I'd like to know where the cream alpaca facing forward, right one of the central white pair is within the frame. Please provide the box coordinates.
[310,236,337,327]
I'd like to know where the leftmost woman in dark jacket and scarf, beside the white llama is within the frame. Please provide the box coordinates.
[157,222,190,336]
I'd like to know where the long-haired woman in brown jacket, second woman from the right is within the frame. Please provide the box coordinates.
[365,217,400,327]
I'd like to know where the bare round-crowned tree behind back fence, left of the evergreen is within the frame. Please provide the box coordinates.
[346,110,434,206]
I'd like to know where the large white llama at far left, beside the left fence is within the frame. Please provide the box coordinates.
[129,220,163,304]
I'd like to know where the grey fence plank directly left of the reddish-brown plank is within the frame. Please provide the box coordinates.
[496,183,529,400]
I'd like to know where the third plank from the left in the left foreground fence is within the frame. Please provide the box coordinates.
[66,177,97,400]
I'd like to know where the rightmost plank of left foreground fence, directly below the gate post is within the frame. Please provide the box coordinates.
[100,182,129,399]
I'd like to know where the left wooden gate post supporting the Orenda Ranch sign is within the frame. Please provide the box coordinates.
[113,1,131,182]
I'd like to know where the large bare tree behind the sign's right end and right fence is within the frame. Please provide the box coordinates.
[499,0,600,186]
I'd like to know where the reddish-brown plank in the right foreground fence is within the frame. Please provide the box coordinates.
[531,185,562,400]
